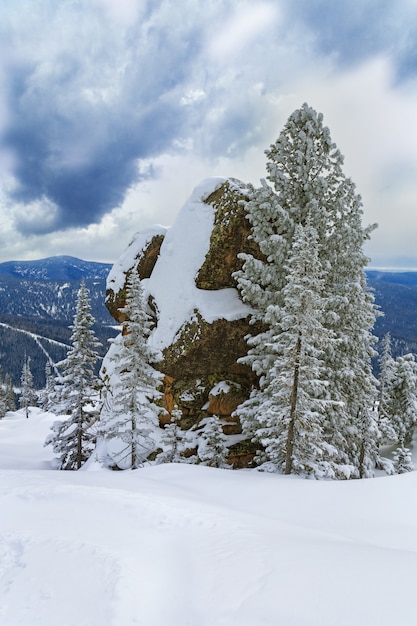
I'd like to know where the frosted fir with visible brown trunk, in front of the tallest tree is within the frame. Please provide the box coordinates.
[239,219,337,477]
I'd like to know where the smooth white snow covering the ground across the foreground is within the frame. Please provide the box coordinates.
[0,409,417,626]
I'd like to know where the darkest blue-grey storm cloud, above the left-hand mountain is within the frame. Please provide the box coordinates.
[6,66,184,232]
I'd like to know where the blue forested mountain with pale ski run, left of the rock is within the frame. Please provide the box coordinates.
[0,256,116,388]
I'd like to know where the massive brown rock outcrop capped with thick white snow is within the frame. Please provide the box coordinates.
[107,179,256,466]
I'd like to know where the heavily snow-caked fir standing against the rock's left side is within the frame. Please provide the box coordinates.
[100,271,163,469]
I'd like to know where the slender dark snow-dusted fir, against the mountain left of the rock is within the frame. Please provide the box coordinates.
[45,282,100,470]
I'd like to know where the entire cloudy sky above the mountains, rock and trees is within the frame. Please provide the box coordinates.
[0,0,417,268]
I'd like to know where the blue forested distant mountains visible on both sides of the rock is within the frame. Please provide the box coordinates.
[0,251,417,388]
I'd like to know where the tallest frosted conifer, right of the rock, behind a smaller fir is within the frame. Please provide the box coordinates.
[235,105,379,476]
